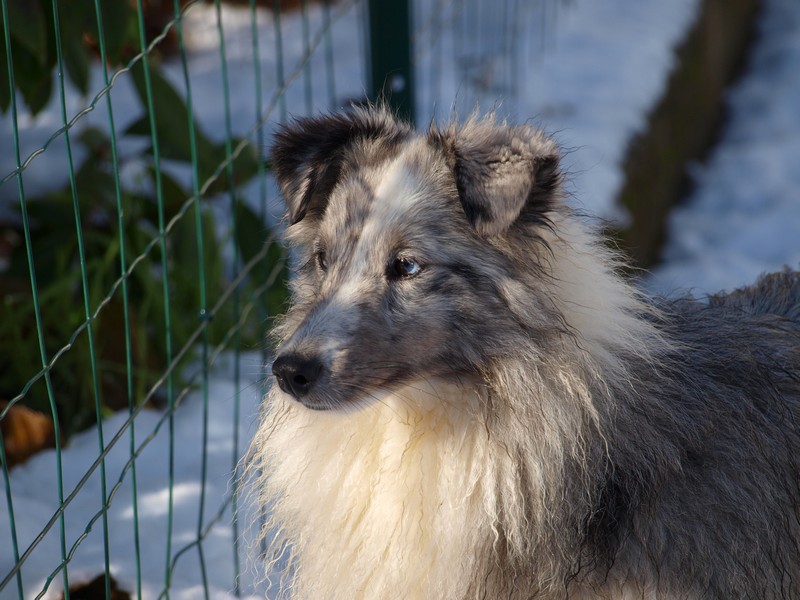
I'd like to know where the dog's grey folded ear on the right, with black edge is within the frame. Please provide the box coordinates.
[440,117,561,237]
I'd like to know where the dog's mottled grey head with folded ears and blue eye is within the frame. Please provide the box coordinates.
[272,110,559,409]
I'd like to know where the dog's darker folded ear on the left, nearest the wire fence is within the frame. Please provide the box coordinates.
[272,109,408,225]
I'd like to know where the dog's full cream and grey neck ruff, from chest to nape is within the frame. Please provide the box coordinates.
[252,216,661,600]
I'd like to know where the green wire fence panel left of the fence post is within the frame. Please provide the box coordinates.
[0,0,364,598]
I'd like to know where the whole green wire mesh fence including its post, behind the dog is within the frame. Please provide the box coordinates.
[0,0,555,599]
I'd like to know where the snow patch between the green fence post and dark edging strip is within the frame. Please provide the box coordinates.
[418,0,698,221]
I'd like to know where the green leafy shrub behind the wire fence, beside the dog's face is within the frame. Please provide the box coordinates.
[0,69,287,435]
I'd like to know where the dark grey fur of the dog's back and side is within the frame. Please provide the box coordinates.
[594,270,800,599]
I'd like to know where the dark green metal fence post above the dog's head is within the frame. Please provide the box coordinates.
[369,0,414,123]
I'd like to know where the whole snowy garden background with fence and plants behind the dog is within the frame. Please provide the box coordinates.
[0,0,800,599]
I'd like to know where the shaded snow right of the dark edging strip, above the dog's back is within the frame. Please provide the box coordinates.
[644,0,800,296]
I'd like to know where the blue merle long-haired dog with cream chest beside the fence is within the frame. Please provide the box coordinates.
[250,107,800,600]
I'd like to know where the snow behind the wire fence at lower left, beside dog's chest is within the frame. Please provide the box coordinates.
[0,353,263,600]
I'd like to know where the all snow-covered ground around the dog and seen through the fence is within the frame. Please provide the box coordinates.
[0,0,800,599]
